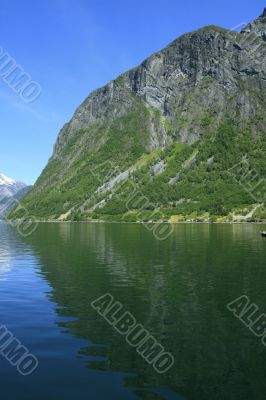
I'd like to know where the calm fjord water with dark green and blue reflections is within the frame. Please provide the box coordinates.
[0,223,266,400]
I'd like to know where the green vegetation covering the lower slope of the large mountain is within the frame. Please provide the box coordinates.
[10,117,266,222]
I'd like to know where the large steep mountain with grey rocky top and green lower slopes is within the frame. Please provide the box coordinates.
[7,9,266,221]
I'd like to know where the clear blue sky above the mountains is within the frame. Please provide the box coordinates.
[0,0,265,184]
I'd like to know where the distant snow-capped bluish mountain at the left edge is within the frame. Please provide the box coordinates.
[0,173,31,219]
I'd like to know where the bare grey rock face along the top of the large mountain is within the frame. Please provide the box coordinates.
[54,9,266,157]
